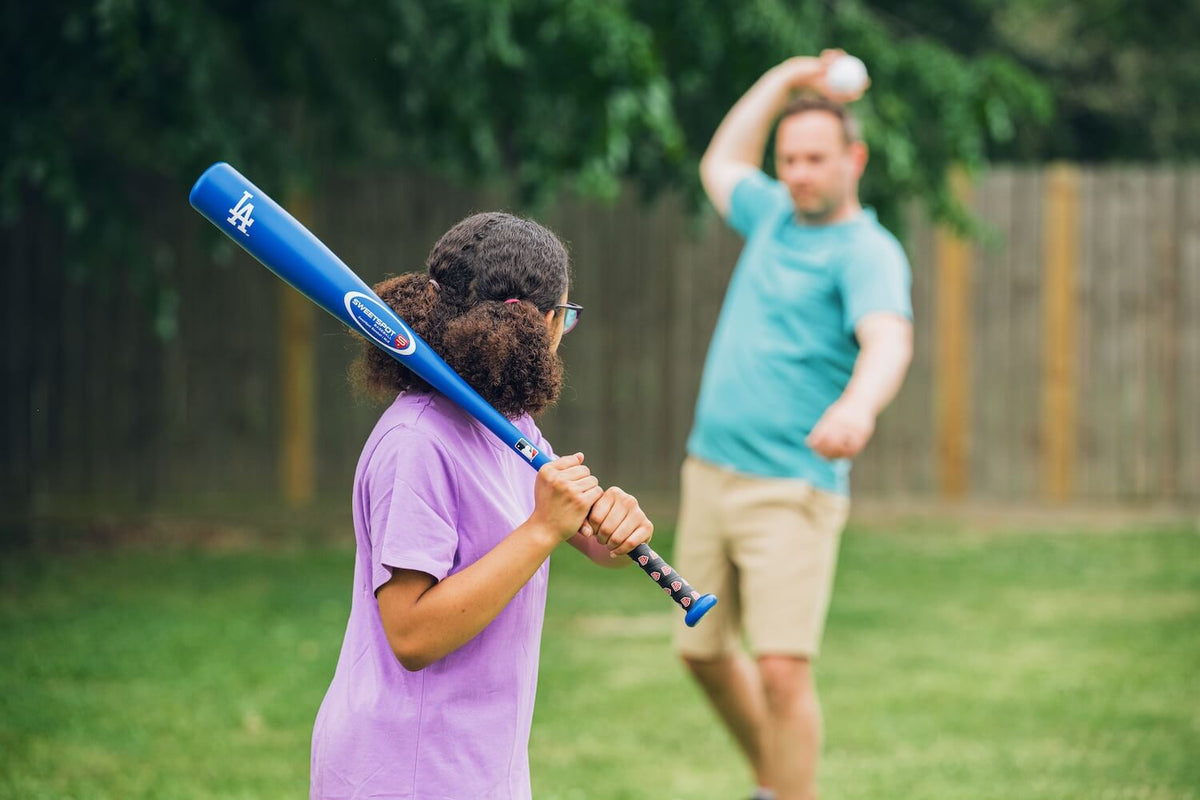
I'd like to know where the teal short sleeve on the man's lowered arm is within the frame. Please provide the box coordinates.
[840,236,912,336]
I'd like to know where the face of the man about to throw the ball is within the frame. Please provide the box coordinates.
[775,110,866,223]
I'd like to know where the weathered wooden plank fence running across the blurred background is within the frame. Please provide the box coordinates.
[0,166,1200,525]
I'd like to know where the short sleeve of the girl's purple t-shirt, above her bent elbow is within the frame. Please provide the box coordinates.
[368,427,458,590]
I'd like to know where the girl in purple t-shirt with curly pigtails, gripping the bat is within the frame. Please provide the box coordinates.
[311,213,653,800]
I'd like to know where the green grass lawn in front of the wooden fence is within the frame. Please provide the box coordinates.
[0,524,1200,800]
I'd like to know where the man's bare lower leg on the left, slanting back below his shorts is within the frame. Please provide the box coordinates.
[683,652,773,787]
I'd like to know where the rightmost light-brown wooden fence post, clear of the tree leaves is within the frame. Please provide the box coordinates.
[1042,164,1079,501]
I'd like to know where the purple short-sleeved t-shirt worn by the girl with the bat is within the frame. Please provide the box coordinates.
[311,393,550,800]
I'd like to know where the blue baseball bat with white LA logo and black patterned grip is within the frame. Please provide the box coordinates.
[188,162,716,626]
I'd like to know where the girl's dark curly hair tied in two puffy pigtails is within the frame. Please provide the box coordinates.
[350,212,570,417]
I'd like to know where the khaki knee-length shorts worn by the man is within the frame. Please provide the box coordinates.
[674,457,850,658]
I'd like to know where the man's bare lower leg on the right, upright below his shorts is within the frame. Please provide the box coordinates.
[758,655,821,800]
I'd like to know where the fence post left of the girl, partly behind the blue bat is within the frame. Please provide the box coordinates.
[278,187,317,509]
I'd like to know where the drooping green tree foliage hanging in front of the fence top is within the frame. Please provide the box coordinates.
[0,0,1051,332]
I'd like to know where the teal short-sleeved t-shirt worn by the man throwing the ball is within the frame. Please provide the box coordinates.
[688,173,912,494]
